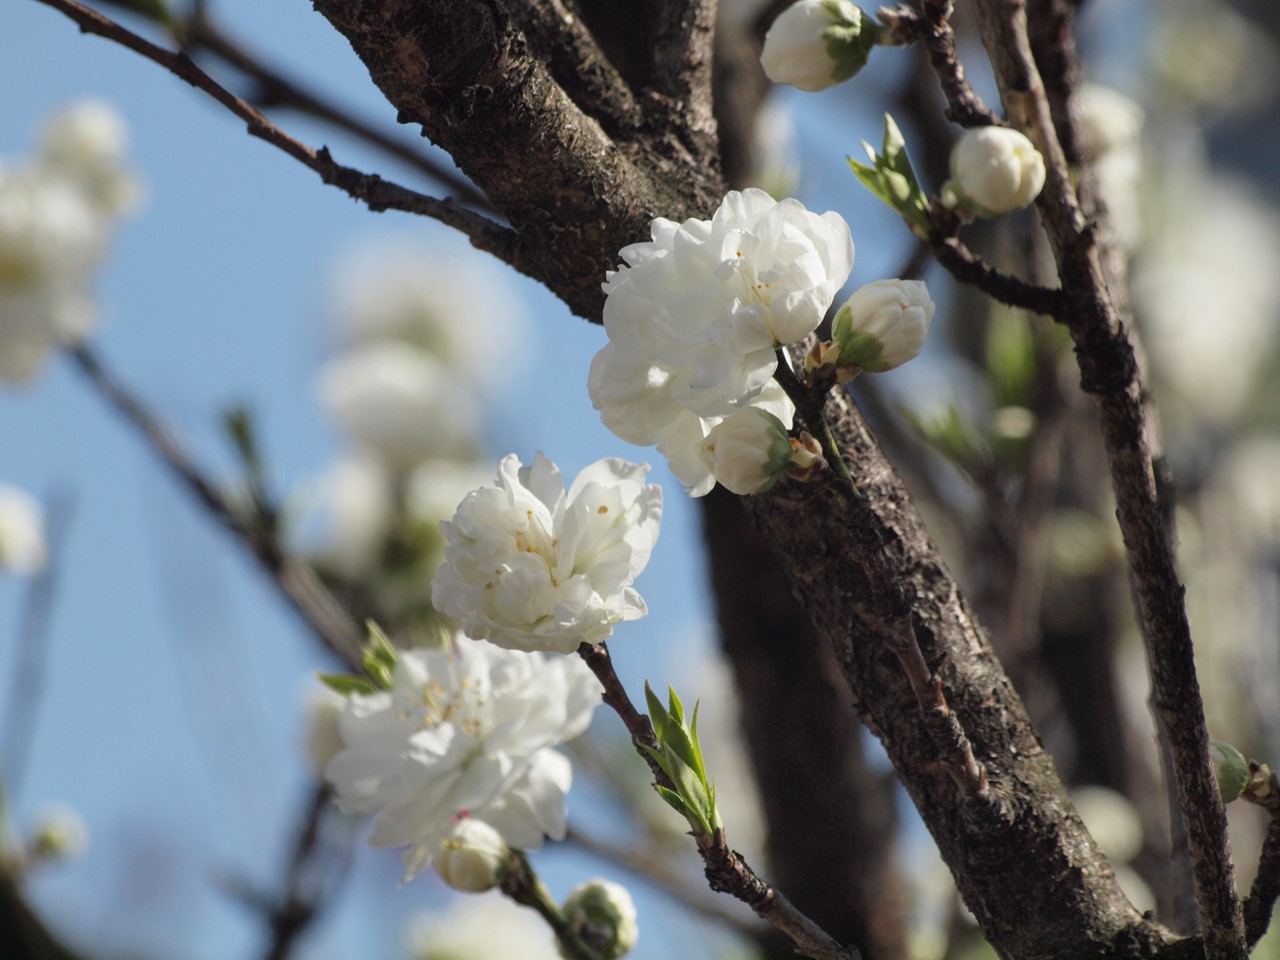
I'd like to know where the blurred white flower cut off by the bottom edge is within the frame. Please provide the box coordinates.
[404,893,562,960]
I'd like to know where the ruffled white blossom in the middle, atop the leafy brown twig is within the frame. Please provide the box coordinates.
[431,453,662,653]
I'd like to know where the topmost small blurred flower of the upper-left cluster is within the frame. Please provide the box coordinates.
[40,100,141,216]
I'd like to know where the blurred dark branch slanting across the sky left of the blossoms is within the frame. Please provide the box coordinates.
[68,344,364,669]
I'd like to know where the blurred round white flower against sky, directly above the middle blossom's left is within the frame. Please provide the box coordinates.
[319,339,480,470]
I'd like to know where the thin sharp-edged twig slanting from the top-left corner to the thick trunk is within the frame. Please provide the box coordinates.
[37,0,520,270]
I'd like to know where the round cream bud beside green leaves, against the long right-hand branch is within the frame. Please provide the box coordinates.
[942,127,1044,218]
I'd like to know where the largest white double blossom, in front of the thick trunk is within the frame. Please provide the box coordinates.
[588,189,854,497]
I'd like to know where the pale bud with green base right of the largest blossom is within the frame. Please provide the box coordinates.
[831,280,933,372]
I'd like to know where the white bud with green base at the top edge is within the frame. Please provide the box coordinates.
[760,0,881,93]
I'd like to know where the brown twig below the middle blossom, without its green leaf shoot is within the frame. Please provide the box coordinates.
[577,644,861,960]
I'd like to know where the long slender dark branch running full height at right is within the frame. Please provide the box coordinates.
[977,0,1248,960]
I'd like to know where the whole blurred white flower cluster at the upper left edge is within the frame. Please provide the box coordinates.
[0,101,138,383]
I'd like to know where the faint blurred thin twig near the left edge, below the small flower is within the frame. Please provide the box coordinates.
[0,492,74,798]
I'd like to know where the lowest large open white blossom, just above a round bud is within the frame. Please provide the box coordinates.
[325,636,600,881]
